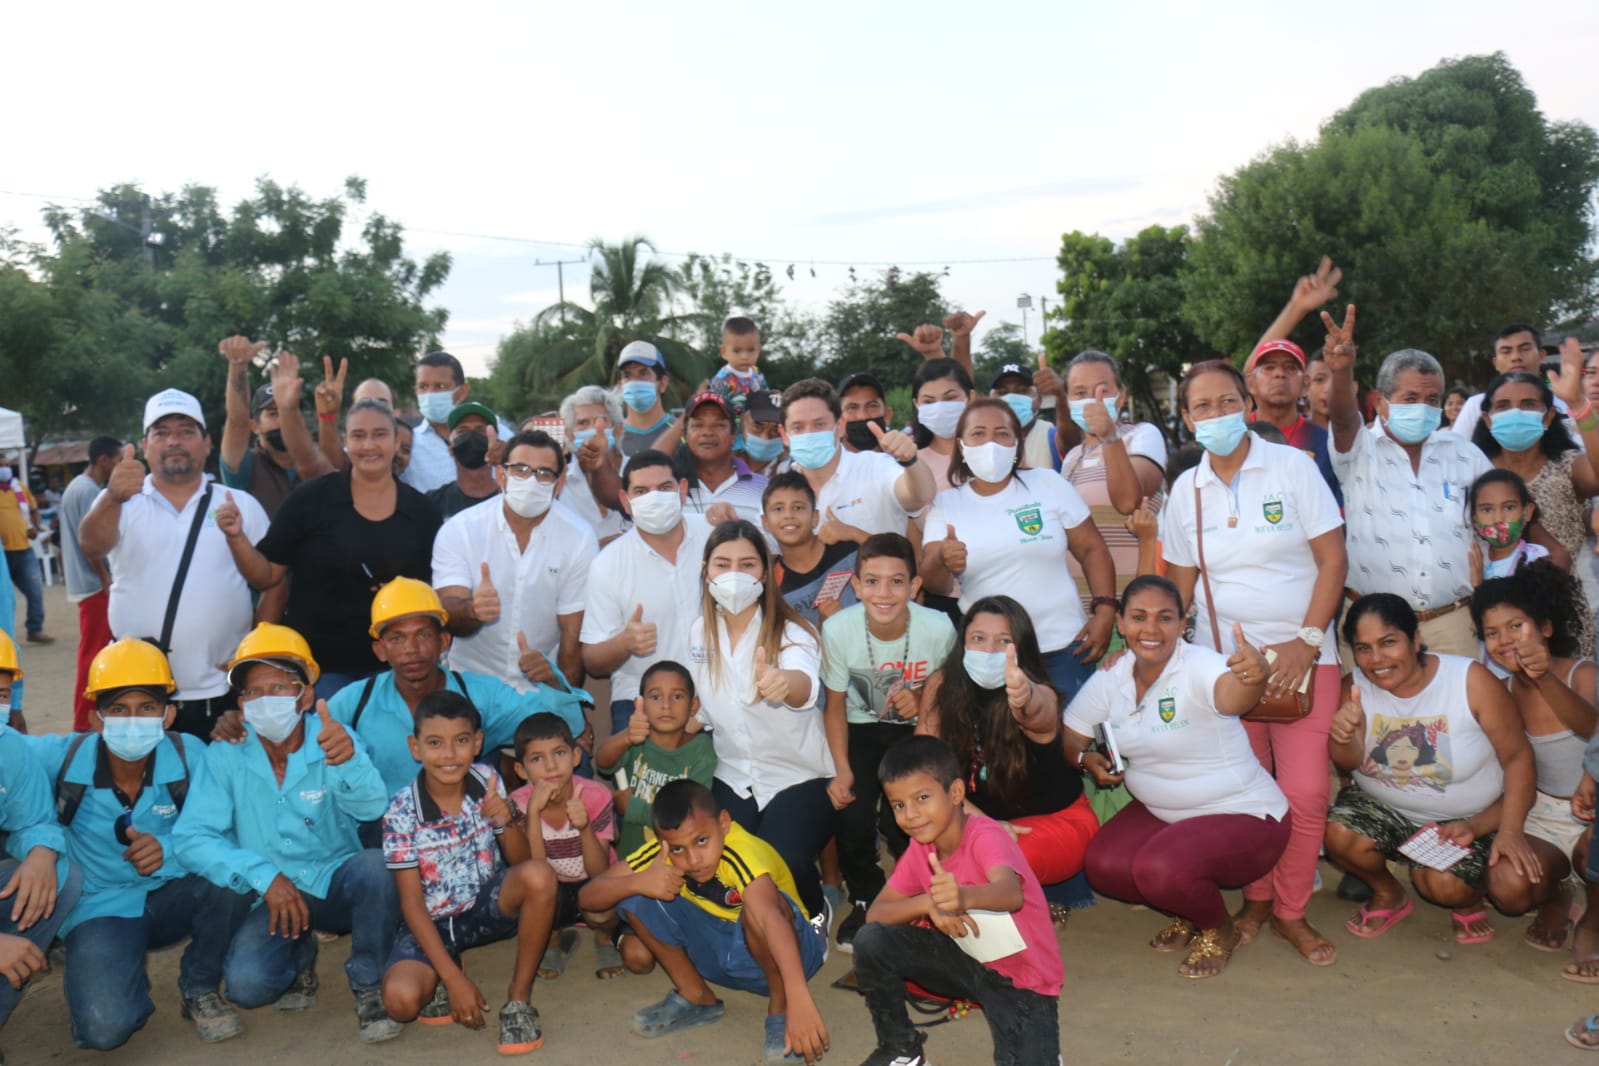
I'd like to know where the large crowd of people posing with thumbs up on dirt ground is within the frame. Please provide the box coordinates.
[0,262,1599,1066]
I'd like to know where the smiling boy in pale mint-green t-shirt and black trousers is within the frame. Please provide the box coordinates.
[822,534,955,953]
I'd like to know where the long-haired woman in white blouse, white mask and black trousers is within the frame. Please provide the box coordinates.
[689,519,836,916]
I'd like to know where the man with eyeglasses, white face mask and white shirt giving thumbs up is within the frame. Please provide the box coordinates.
[433,430,600,692]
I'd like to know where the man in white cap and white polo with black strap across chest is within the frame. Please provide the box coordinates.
[78,388,271,738]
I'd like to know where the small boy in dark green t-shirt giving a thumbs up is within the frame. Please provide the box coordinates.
[595,660,716,855]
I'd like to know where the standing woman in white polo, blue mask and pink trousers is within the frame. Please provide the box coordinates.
[1161,360,1348,965]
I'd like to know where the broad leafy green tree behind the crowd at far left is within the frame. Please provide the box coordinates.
[0,177,449,436]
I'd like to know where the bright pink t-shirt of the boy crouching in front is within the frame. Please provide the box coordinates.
[889,815,1065,996]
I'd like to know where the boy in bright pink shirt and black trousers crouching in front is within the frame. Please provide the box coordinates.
[855,737,1065,1066]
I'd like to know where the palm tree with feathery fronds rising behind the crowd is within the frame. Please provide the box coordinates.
[521,237,710,412]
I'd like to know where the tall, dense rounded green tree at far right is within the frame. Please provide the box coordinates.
[1183,54,1599,379]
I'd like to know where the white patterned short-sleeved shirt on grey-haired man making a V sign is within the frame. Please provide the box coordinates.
[1330,420,1492,611]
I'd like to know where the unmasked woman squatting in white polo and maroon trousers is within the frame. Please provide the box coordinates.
[1065,577,1292,978]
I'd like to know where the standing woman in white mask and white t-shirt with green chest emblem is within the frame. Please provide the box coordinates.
[921,398,1116,700]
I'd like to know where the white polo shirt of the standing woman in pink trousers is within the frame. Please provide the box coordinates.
[1161,436,1343,663]
